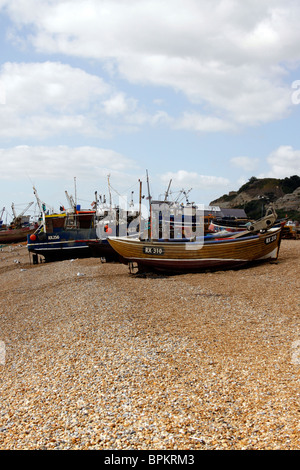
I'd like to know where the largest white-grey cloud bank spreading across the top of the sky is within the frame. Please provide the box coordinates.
[1,0,300,126]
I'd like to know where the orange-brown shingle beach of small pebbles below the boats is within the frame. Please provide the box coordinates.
[0,240,300,450]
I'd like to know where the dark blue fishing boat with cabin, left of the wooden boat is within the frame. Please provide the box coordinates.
[27,200,143,262]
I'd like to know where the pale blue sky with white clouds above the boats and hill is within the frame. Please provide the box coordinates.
[0,0,300,222]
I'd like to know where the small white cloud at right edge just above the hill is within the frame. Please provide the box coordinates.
[265,145,300,178]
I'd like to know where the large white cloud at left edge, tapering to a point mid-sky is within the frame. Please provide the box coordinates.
[0,61,155,140]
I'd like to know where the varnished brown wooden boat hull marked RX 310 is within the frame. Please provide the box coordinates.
[108,228,281,272]
